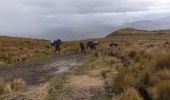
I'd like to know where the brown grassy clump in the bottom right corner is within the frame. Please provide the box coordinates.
[155,80,170,100]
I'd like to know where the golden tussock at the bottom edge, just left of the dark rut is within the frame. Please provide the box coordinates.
[116,88,143,100]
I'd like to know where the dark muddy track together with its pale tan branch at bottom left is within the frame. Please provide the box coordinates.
[0,54,83,100]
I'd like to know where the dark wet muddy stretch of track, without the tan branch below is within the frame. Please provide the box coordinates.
[0,54,83,85]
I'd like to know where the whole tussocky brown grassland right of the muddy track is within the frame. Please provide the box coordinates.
[46,36,170,100]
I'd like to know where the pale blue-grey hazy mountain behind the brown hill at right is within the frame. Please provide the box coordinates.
[120,16,170,30]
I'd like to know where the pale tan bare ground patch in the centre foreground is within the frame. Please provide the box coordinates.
[67,75,104,100]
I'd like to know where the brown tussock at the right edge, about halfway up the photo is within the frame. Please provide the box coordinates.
[154,54,170,69]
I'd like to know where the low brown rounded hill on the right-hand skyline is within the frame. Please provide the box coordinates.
[107,28,170,37]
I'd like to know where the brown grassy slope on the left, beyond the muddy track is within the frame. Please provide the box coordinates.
[0,36,79,66]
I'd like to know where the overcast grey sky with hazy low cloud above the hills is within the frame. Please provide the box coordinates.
[0,0,170,39]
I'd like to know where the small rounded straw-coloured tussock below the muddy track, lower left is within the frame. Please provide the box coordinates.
[11,79,26,91]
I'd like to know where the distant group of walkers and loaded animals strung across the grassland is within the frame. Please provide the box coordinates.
[51,39,118,54]
